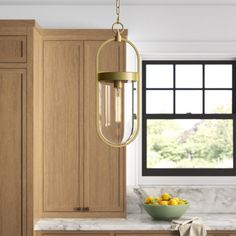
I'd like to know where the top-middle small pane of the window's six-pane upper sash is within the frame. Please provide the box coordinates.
[176,65,203,88]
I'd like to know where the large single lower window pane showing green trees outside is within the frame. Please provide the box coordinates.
[147,119,233,169]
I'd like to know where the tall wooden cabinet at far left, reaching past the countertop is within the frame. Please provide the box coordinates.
[0,20,36,236]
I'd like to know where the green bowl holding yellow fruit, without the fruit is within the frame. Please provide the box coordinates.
[143,204,189,221]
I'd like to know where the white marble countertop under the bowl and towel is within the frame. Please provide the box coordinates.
[34,213,236,231]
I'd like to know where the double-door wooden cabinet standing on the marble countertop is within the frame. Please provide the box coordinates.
[35,33,125,217]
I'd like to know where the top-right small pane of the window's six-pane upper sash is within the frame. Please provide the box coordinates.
[205,65,232,88]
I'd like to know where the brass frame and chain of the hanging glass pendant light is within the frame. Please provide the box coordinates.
[96,0,141,147]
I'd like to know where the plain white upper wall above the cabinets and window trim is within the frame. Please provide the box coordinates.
[0,3,236,41]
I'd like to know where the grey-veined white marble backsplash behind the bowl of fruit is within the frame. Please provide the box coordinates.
[127,186,236,213]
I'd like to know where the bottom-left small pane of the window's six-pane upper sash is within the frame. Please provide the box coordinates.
[146,91,173,114]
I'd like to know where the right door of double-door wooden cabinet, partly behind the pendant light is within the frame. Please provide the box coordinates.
[84,41,125,212]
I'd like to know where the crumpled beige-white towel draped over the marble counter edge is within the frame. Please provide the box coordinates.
[171,217,207,236]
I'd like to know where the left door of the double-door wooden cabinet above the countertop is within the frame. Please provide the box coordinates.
[43,41,83,212]
